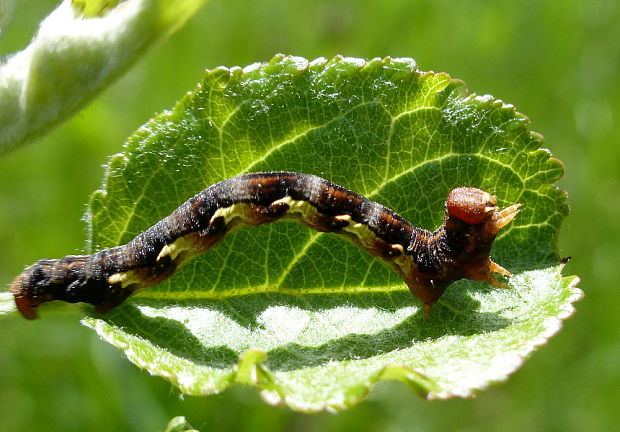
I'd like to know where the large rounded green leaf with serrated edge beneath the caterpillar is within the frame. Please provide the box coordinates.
[78,56,582,411]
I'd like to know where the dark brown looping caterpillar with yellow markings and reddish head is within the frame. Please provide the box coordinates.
[10,171,520,319]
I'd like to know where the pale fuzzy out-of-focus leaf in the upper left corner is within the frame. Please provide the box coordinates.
[0,0,205,154]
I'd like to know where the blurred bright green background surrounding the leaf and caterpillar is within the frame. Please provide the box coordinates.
[0,0,620,431]
